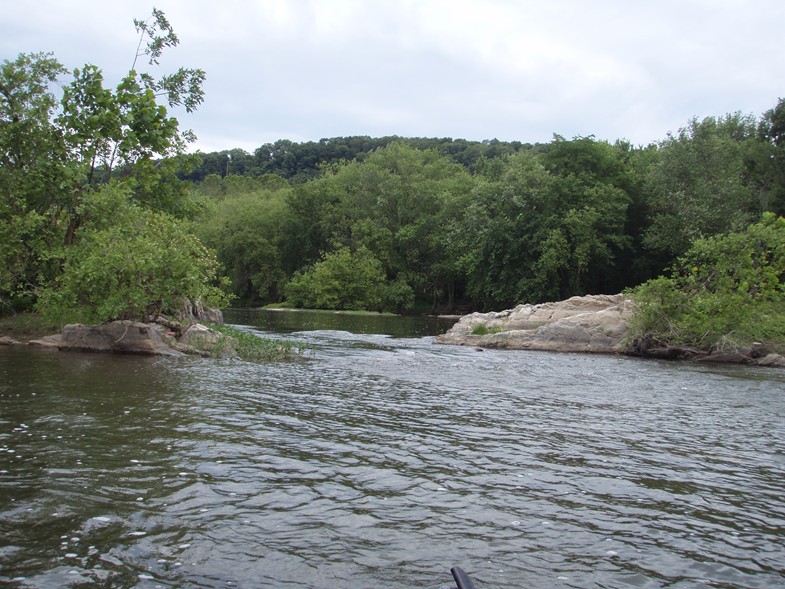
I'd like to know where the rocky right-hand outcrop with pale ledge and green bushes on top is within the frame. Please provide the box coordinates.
[437,214,785,367]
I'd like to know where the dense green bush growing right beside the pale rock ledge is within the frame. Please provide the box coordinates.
[630,213,785,349]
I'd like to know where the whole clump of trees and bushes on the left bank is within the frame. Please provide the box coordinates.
[0,10,223,321]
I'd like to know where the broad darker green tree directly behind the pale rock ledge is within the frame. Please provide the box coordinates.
[462,138,630,308]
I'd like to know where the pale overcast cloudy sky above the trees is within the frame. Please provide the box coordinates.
[0,0,785,152]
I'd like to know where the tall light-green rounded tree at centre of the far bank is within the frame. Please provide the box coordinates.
[324,142,472,308]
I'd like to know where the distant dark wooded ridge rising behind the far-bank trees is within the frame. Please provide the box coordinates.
[181,136,532,183]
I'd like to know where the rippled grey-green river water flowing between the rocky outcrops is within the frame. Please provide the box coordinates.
[0,312,785,589]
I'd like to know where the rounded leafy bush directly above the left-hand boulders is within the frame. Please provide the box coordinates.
[38,187,227,323]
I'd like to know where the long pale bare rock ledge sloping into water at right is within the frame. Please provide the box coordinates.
[436,295,633,353]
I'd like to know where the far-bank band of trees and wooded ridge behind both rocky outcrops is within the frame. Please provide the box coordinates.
[194,100,785,311]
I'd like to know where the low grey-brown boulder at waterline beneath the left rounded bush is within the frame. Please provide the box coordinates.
[60,321,181,356]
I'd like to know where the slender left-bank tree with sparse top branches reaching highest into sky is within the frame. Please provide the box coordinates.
[54,9,205,234]
